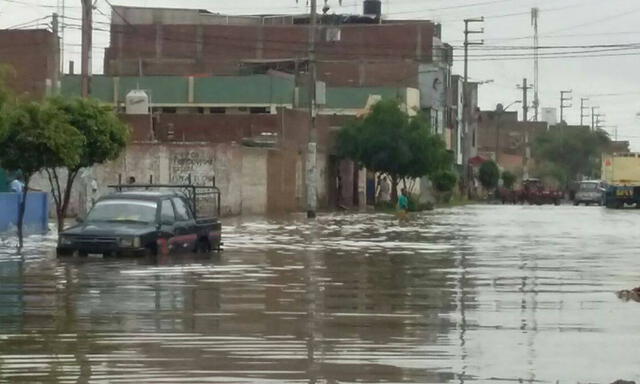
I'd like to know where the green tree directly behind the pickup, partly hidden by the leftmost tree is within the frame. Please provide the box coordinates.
[45,98,129,230]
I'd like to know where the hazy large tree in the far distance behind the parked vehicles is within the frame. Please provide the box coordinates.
[532,125,611,186]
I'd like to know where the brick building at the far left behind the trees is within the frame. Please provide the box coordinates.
[0,29,60,98]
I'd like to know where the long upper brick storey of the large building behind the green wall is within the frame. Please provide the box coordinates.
[104,6,439,88]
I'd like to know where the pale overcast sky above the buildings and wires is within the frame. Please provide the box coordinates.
[0,0,640,150]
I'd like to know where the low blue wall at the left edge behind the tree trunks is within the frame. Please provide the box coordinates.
[0,192,49,234]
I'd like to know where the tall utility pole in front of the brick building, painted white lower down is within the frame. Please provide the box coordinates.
[306,0,318,219]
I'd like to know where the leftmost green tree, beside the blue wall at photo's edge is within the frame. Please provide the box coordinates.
[0,101,84,247]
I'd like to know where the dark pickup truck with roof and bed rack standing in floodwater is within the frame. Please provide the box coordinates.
[57,186,222,256]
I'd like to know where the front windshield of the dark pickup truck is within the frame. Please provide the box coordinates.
[86,200,158,223]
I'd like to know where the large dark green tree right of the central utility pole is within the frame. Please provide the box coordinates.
[336,100,453,201]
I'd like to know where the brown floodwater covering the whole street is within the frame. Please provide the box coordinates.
[0,206,640,383]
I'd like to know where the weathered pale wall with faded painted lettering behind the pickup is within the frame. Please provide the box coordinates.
[31,143,331,216]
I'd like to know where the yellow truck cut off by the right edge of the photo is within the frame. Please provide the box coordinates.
[602,153,640,209]
